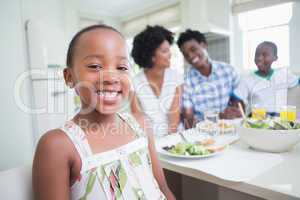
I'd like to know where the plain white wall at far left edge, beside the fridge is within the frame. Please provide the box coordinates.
[0,0,32,170]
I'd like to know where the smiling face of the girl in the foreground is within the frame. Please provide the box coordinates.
[65,28,130,114]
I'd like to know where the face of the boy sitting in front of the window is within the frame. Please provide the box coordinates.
[254,44,277,74]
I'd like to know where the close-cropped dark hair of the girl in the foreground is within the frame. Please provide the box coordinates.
[66,24,122,67]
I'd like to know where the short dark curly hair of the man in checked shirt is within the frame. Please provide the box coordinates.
[177,29,207,48]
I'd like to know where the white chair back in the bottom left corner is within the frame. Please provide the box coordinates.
[0,166,33,200]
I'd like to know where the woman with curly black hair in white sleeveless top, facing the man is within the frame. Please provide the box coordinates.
[131,26,183,136]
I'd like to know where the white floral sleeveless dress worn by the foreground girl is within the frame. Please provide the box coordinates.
[61,114,166,200]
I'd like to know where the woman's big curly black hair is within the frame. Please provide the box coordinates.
[131,25,174,68]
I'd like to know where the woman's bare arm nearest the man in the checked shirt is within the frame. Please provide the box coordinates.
[168,86,182,133]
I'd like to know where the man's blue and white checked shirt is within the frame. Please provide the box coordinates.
[182,61,239,120]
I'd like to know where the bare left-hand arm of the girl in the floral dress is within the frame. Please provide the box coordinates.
[32,130,70,200]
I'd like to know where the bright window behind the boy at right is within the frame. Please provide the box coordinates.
[238,3,292,69]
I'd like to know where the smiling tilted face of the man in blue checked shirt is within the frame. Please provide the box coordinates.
[180,39,208,69]
